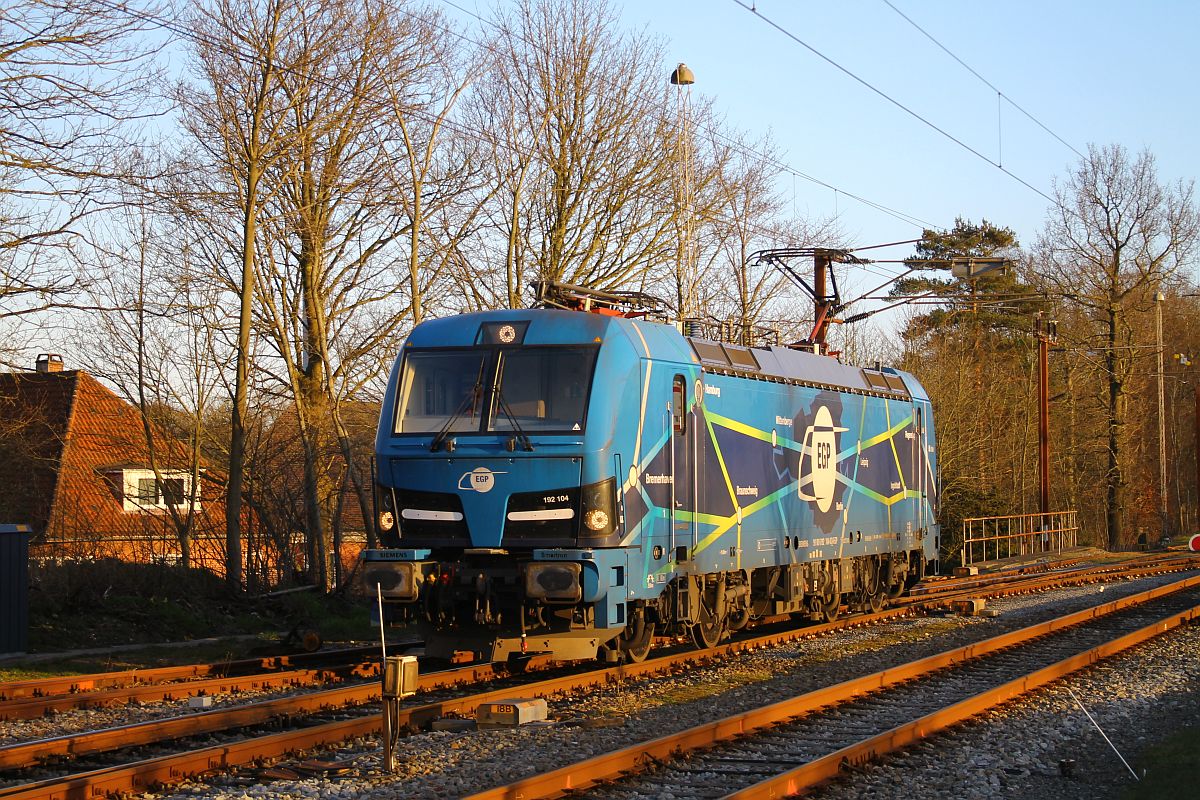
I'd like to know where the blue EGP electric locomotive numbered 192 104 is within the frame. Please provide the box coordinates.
[364,287,938,661]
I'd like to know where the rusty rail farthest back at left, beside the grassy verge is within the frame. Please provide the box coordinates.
[0,645,379,700]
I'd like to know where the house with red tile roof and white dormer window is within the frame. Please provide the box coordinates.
[0,355,234,573]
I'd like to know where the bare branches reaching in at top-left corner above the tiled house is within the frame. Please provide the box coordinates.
[0,0,164,357]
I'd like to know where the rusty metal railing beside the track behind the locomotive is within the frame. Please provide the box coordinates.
[959,511,1079,566]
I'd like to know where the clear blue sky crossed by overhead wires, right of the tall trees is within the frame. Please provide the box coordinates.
[623,0,1200,257]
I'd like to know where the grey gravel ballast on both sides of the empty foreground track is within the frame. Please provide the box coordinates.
[14,575,1200,800]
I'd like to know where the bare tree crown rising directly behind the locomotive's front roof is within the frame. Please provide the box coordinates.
[472,0,674,297]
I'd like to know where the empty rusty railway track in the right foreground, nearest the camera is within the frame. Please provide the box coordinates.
[470,577,1200,800]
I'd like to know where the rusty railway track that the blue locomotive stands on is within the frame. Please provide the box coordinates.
[0,559,1200,800]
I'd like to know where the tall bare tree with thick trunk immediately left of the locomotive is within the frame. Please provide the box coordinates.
[248,0,462,587]
